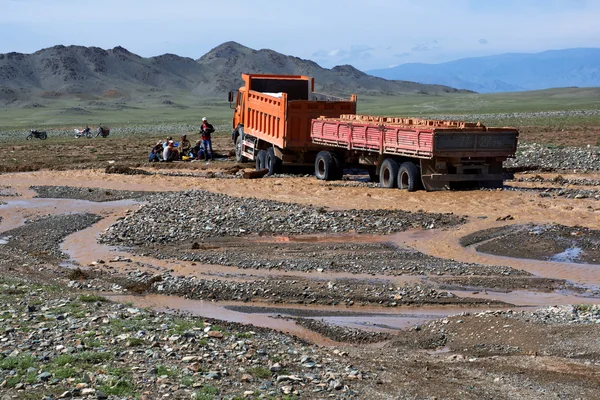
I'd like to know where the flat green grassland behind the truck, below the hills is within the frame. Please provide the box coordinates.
[0,88,600,132]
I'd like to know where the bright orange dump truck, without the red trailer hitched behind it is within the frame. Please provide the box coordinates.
[229,74,356,175]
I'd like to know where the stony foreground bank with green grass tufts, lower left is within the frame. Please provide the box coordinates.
[0,278,374,400]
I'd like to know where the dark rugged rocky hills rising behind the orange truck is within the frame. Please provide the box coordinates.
[0,42,466,105]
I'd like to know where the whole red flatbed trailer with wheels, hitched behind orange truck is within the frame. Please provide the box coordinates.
[311,114,519,191]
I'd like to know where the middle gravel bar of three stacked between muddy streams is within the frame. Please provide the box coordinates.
[135,239,528,276]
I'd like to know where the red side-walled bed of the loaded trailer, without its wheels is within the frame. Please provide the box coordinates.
[311,114,518,159]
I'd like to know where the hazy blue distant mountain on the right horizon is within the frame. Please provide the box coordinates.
[367,48,600,93]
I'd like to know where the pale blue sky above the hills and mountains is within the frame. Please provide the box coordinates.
[0,0,600,70]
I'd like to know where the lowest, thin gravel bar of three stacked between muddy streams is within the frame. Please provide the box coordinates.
[127,271,503,307]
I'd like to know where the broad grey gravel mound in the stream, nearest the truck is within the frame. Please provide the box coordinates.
[100,190,464,246]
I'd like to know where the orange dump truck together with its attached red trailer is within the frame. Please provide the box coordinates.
[229,74,518,191]
